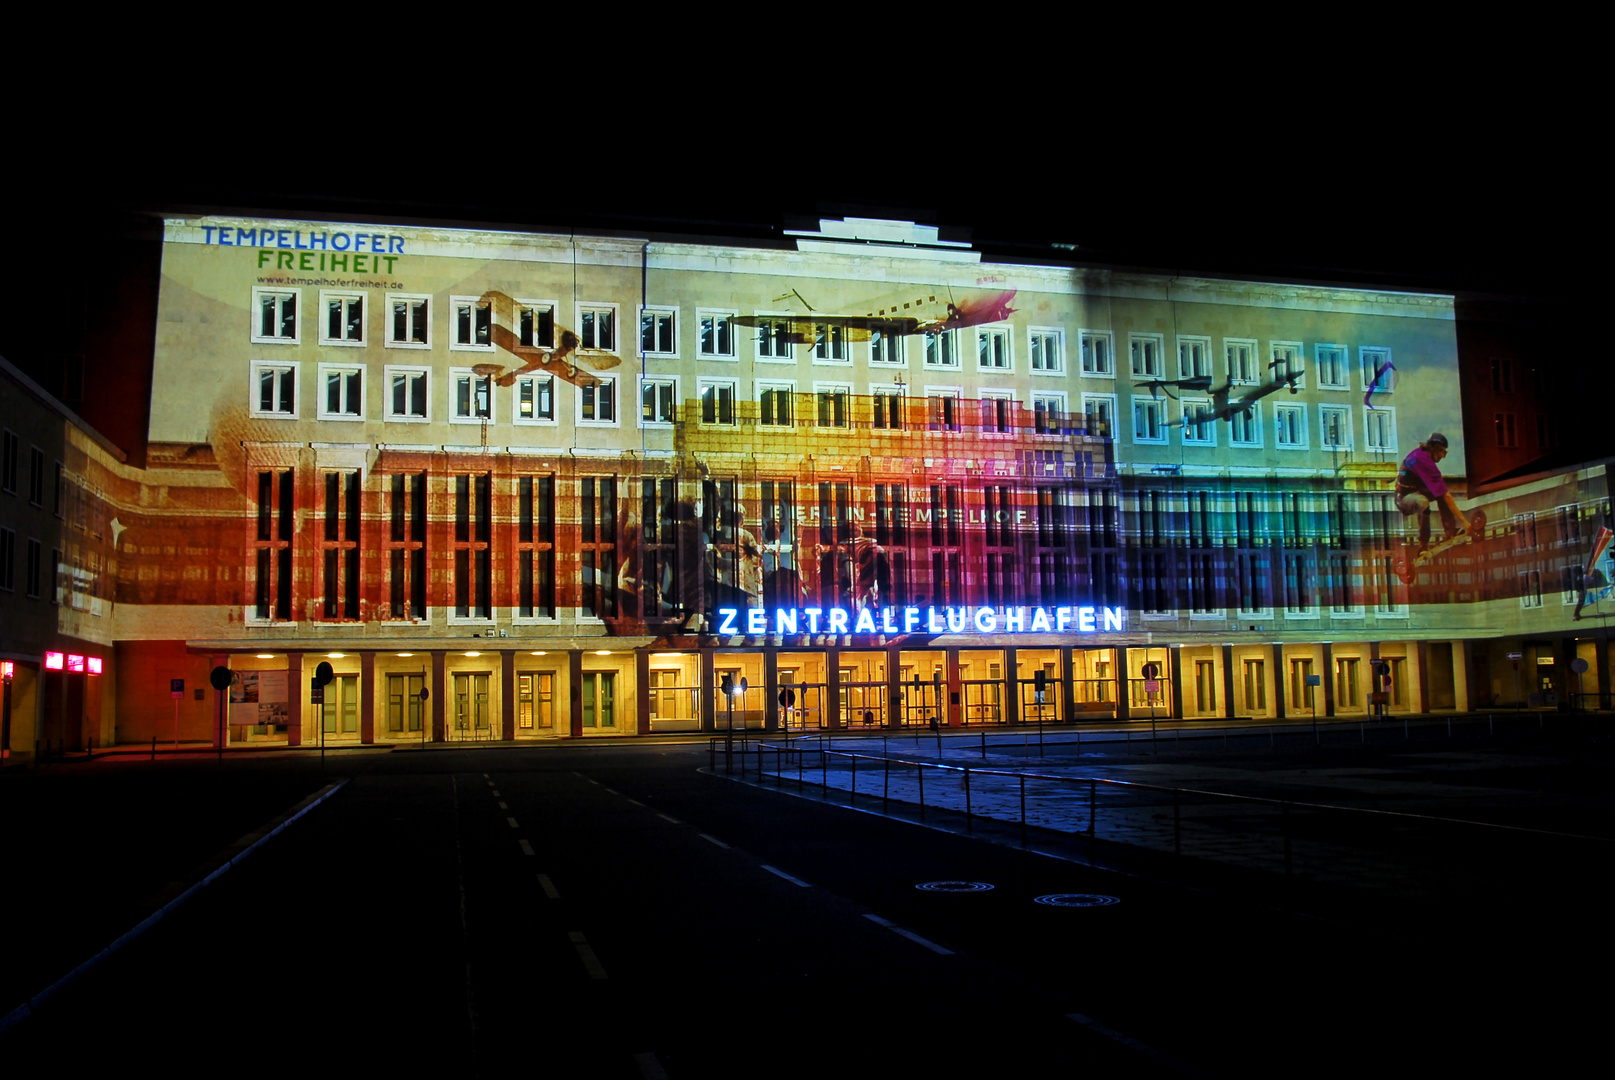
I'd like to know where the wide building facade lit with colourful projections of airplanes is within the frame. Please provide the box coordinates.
[6,218,1609,744]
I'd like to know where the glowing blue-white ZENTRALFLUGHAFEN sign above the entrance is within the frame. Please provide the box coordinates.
[717,607,1122,634]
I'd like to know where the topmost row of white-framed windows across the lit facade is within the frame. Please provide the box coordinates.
[242,286,1394,392]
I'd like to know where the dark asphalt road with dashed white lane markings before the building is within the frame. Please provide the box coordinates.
[0,744,1610,1078]
